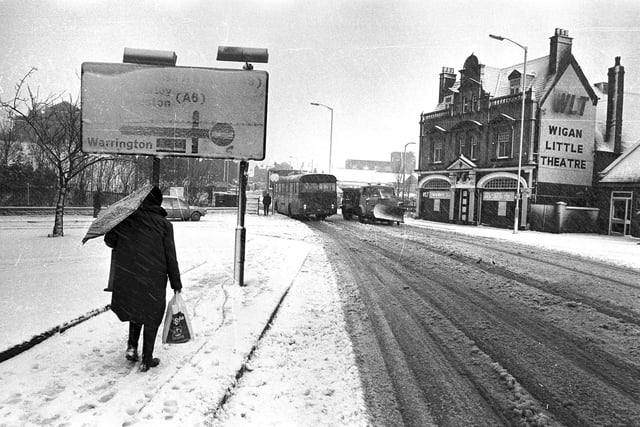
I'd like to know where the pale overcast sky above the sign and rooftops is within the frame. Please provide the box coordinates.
[0,0,640,169]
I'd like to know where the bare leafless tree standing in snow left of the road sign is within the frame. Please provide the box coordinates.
[0,69,102,237]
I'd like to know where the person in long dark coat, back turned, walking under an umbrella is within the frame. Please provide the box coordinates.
[104,186,182,372]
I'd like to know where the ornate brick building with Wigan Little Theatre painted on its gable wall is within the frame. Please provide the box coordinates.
[417,29,598,229]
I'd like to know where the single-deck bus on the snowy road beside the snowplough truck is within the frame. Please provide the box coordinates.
[272,173,338,220]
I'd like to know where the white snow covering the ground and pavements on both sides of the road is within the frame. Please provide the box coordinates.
[0,211,640,426]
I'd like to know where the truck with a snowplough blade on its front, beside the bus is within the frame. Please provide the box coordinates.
[340,184,404,225]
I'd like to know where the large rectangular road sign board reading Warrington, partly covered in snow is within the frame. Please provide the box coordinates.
[81,62,269,160]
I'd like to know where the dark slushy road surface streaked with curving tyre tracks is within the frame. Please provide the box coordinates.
[315,221,640,425]
